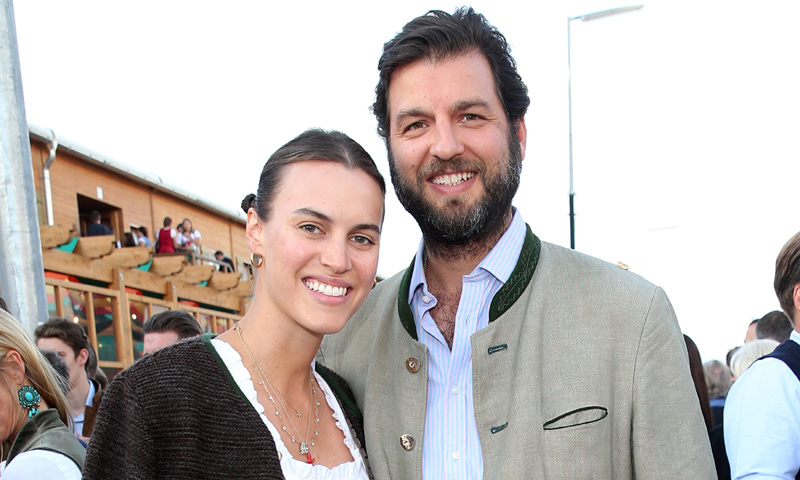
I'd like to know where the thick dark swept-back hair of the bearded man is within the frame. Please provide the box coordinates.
[372,7,531,141]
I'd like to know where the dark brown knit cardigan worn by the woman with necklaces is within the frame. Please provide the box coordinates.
[83,334,368,480]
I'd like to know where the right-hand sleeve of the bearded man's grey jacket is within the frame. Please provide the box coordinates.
[631,288,717,480]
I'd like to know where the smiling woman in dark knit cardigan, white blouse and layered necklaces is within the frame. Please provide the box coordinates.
[84,130,386,479]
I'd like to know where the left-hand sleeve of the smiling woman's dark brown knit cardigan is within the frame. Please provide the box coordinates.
[83,372,156,480]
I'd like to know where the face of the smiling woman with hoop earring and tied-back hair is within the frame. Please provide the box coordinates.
[247,160,383,335]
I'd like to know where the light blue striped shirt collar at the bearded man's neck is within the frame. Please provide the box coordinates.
[408,207,525,305]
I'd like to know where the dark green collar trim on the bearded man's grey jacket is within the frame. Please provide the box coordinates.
[397,224,542,340]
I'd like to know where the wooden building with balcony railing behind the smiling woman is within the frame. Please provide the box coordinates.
[30,126,253,374]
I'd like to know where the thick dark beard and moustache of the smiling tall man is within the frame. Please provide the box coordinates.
[388,128,522,254]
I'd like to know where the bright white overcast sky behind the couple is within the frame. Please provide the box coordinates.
[14,0,800,360]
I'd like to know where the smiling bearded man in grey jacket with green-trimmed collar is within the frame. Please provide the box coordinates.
[318,9,716,479]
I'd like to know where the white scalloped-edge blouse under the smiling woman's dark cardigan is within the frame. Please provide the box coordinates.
[208,338,369,480]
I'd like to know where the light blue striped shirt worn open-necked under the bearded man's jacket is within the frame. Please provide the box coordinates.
[409,209,525,480]
